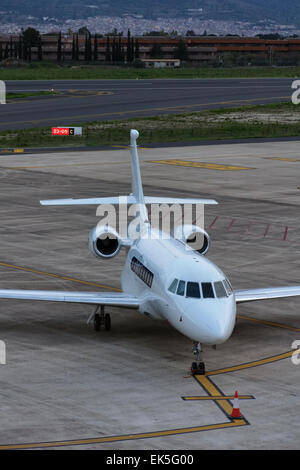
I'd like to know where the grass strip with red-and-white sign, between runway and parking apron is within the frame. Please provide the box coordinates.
[0,103,300,148]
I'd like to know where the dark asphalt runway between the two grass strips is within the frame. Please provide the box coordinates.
[0,79,293,130]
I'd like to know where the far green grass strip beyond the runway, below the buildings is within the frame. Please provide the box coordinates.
[0,63,300,80]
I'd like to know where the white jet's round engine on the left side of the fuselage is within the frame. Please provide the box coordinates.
[89,225,122,258]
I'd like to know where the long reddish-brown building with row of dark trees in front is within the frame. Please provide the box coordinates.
[0,33,300,67]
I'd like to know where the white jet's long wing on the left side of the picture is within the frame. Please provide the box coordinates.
[0,289,140,309]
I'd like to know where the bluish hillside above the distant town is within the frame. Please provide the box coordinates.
[0,0,300,26]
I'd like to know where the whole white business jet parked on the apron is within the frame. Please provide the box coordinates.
[0,130,300,374]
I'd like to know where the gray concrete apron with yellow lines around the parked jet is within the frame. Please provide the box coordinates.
[0,140,300,450]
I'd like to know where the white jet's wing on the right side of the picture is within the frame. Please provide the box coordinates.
[234,286,300,304]
